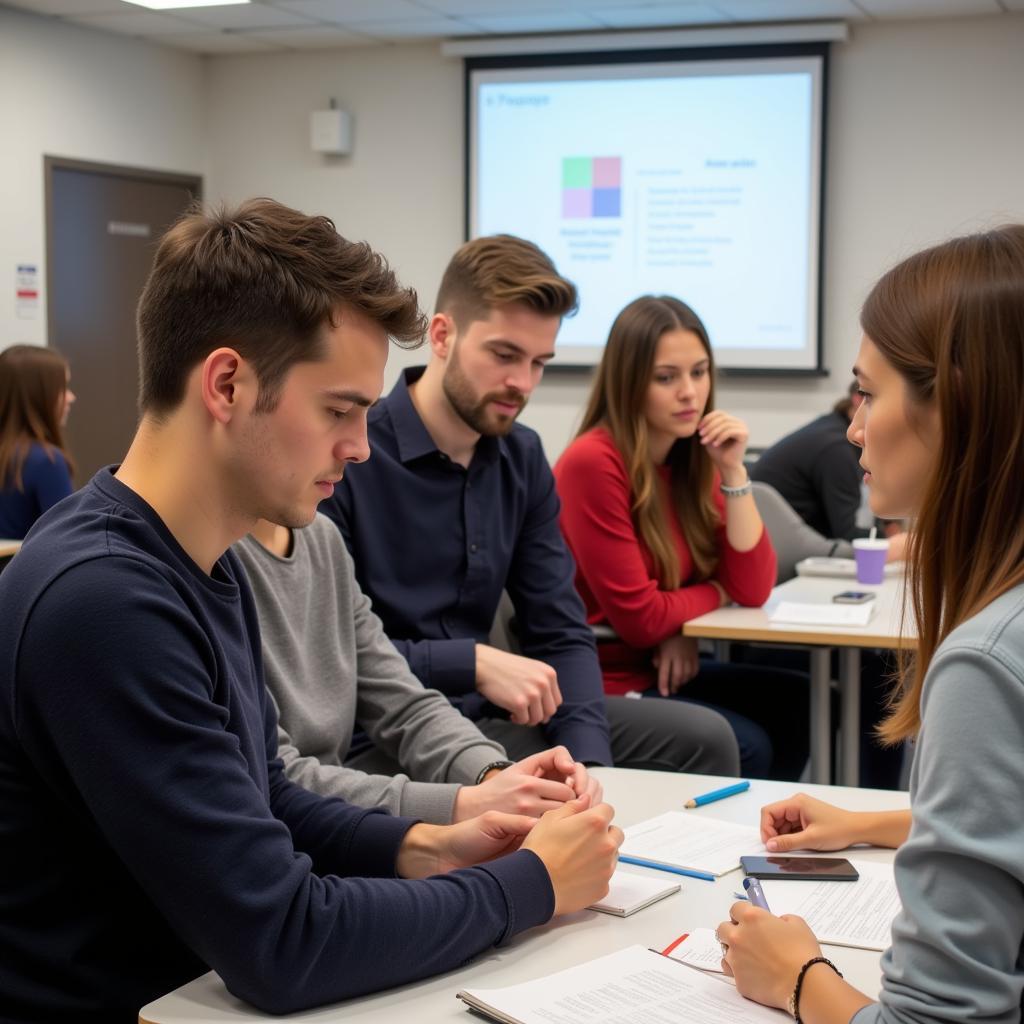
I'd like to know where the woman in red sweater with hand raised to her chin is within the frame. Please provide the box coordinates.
[555,295,808,779]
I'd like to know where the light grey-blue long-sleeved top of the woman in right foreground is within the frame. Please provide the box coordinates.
[853,586,1024,1024]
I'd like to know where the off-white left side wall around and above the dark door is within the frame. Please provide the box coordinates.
[0,9,205,348]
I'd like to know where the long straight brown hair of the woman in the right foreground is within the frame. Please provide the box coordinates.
[860,225,1024,742]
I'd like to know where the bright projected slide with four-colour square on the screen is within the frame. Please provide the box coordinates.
[471,59,820,369]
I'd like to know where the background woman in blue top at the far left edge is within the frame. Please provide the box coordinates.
[0,345,75,540]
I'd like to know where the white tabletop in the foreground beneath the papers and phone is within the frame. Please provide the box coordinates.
[139,768,908,1024]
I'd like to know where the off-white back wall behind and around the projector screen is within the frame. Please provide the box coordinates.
[201,15,1024,458]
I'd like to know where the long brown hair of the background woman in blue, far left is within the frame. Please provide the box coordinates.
[0,345,75,490]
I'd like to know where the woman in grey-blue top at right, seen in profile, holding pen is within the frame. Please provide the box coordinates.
[718,225,1024,1024]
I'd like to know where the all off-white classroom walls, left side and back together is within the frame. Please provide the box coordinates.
[0,10,1024,458]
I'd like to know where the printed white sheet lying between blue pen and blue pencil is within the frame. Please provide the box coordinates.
[618,811,764,878]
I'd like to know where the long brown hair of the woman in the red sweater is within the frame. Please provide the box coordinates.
[578,295,719,590]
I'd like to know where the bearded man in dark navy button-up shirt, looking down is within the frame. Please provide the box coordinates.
[322,234,738,775]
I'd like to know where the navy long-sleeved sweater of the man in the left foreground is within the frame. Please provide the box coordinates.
[0,470,553,1022]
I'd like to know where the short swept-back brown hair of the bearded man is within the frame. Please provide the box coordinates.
[434,234,579,327]
